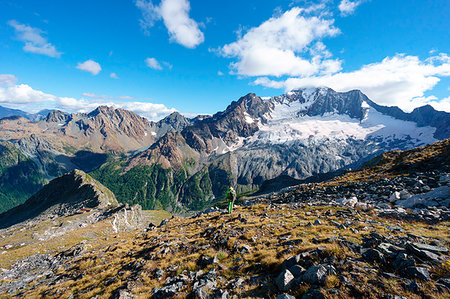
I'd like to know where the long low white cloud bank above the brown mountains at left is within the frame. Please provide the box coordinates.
[0,75,176,120]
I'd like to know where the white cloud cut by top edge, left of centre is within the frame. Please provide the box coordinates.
[136,0,205,49]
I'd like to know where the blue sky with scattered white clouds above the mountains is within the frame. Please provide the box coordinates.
[0,0,450,120]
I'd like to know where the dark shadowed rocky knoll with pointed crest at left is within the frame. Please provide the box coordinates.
[0,170,118,228]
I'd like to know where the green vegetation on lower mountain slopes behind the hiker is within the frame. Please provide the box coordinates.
[90,159,234,212]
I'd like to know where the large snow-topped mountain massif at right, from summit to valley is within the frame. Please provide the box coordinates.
[94,88,450,210]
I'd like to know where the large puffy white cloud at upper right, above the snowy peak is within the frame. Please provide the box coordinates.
[219,7,341,76]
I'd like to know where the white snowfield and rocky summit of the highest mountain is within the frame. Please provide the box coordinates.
[231,88,437,149]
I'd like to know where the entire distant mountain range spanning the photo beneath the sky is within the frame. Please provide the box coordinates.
[0,88,450,213]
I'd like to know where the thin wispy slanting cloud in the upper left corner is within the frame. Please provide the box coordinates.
[8,20,61,57]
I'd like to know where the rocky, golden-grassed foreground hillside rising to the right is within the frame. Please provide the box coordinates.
[0,140,450,298]
